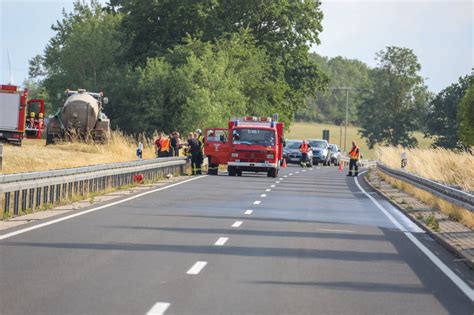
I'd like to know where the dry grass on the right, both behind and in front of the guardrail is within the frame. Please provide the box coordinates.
[378,147,474,229]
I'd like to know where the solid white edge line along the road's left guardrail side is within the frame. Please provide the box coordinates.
[0,175,208,241]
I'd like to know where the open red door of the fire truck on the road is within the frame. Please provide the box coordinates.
[204,128,230,175]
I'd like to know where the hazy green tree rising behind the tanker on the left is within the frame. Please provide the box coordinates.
[29,0,122,107]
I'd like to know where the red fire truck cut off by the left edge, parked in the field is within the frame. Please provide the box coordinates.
[0,85,44,145]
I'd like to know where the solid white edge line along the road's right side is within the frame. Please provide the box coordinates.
[354,171,474,301]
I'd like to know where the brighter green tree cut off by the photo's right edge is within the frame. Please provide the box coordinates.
[458,76,474,148]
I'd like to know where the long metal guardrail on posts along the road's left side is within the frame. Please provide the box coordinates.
[0,157,186,216]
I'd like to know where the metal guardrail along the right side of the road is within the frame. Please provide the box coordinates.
[377,162,474,211]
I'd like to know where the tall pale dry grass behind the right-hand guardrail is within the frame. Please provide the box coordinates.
[377,147,474,191]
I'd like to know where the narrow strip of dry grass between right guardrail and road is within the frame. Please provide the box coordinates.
[378,172,474,229]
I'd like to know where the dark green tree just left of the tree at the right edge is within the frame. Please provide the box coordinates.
[425,76,471,149]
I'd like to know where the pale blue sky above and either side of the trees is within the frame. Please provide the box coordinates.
[0,0,474,92]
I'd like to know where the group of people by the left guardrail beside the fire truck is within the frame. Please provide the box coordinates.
[155,129,204,175]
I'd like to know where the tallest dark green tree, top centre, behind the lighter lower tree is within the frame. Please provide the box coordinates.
[109,0,326,121]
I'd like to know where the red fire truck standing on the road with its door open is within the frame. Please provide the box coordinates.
[204,116,284,177]
